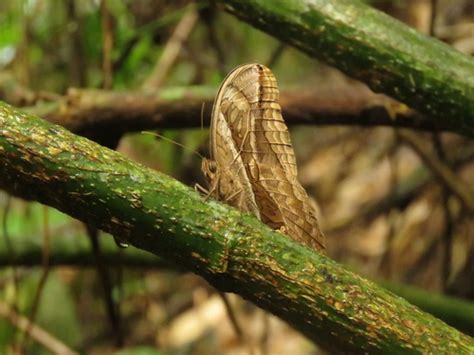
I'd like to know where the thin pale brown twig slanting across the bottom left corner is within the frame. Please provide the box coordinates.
[0,301,77,355]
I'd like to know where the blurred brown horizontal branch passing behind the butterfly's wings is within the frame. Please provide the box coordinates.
[27,86,449,138]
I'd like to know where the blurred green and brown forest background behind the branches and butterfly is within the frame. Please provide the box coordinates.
[0,0,474,354]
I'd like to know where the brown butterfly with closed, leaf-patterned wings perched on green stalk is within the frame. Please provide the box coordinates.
[202,64,324,250]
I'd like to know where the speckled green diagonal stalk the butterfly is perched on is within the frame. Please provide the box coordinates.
[0,103,474,354]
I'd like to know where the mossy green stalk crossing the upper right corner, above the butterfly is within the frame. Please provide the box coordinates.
[219,0,474,137]
